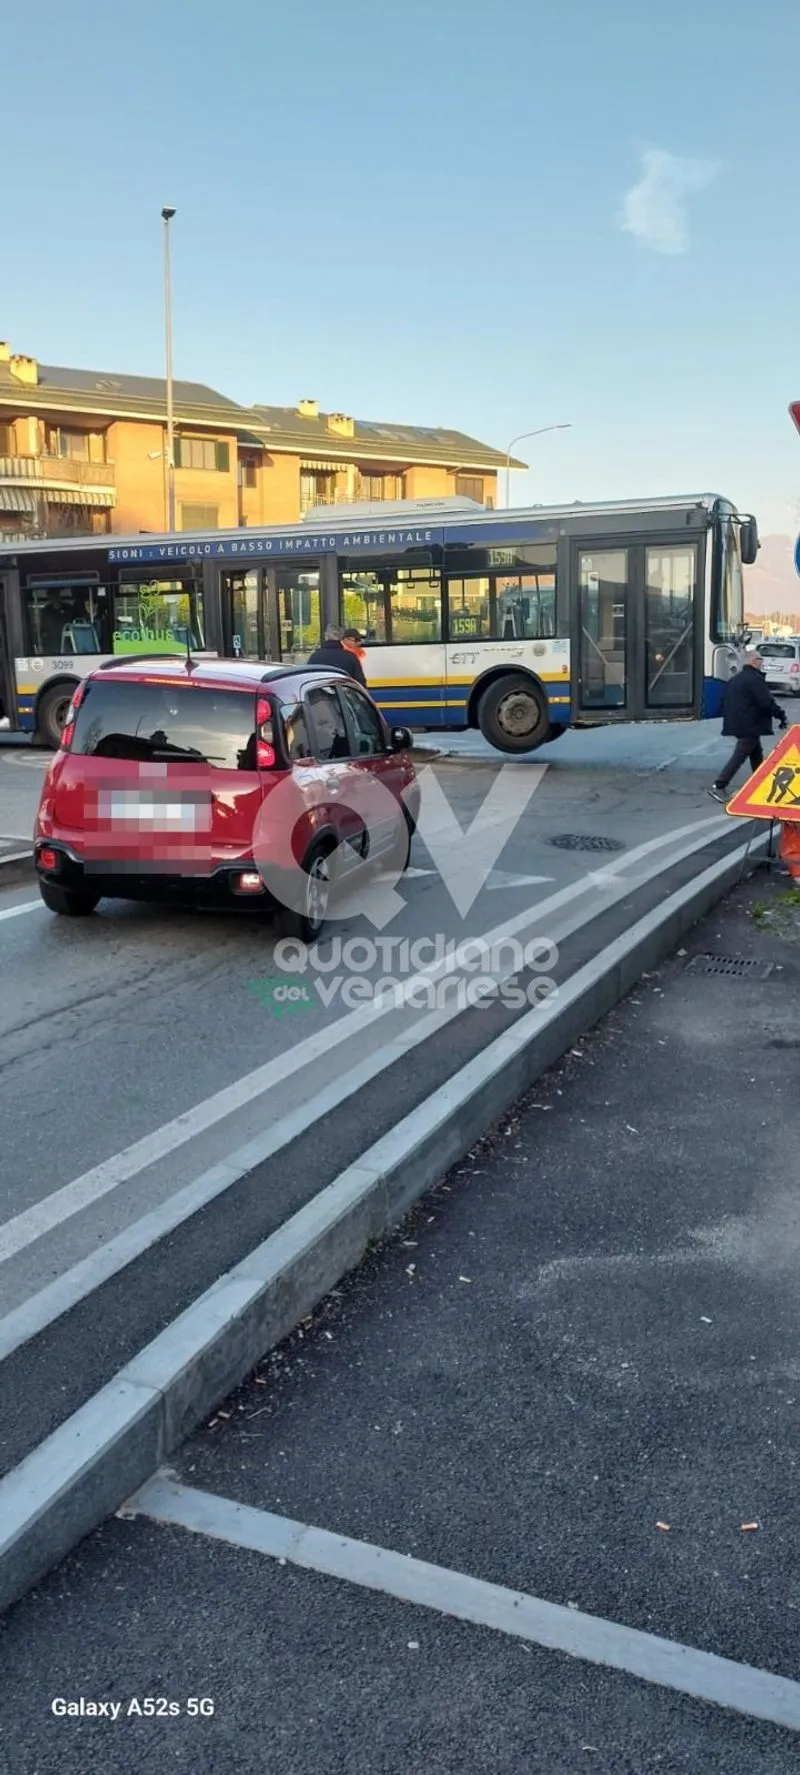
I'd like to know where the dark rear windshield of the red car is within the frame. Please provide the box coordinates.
[69,676,255,770]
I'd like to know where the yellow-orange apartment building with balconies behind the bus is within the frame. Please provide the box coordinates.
[0,343,525,541]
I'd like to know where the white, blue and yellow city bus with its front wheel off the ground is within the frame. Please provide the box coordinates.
[0,493,759,753]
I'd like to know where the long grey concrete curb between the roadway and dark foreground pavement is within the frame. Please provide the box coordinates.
[0,823,766,1610]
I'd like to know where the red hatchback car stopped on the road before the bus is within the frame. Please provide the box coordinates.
[34,655,419,941]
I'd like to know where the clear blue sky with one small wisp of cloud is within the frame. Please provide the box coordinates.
[0,0,800,533]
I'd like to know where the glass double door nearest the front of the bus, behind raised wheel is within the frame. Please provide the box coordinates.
[571,534,702,722]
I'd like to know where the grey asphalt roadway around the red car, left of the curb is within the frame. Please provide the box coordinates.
[0,726,759,1334]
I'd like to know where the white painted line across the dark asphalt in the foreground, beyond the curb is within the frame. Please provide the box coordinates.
[126,1475,800,1732]
